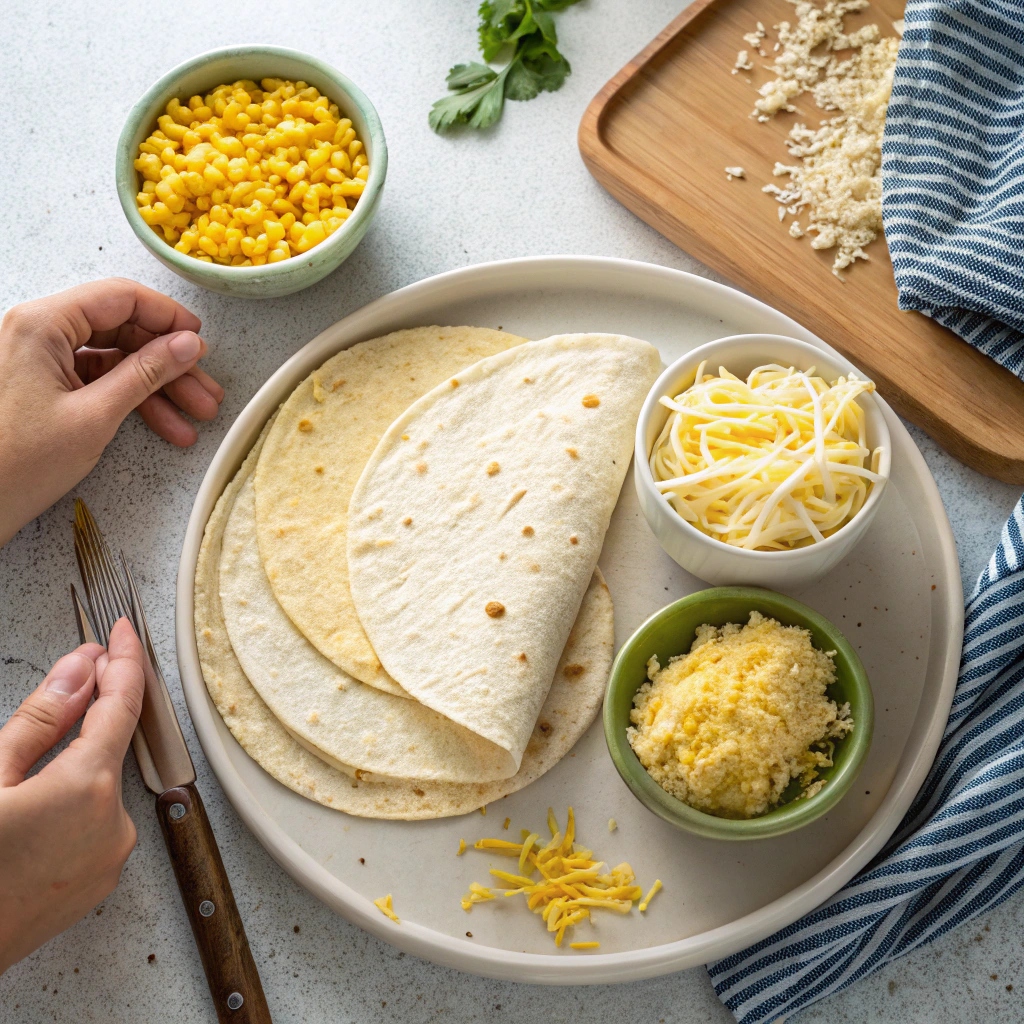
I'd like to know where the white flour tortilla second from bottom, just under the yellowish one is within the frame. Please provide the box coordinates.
[219,479,519,782]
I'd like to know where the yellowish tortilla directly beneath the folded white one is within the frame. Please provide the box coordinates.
[255,327,524,695]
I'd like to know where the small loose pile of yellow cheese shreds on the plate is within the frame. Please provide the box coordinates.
[462,807,660,949]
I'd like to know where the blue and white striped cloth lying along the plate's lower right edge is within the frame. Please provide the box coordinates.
[708,498,1024,1024]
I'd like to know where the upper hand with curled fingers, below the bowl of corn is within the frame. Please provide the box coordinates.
[0,278,224,546]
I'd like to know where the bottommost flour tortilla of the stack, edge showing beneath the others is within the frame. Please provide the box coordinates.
[195,428,613,820]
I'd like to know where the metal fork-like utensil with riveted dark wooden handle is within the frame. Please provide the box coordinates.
[72,500,271,1024]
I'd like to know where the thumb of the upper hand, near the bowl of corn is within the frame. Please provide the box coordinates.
[74,331,206,435]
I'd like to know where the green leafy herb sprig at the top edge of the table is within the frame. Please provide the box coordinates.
[430,0,579,132]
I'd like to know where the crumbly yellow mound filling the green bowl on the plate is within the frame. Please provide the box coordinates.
[627,611,854,819]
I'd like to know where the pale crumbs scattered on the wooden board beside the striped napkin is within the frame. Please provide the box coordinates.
[743,0,899,281]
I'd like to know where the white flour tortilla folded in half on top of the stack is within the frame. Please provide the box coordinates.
[348,334,660,766]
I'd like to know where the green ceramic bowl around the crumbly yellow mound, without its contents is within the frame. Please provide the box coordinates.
[604,587,874,840]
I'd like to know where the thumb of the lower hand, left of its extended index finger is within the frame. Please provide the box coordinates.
[0,644,103,787]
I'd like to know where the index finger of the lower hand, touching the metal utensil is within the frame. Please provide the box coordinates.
[75,618,145,778]
